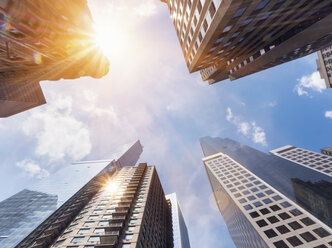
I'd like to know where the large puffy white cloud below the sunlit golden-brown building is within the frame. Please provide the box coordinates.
[22,96,91,161]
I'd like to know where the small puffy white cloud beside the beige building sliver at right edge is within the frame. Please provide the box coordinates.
[295,71,326,96]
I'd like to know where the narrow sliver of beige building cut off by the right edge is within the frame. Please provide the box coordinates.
[316,46,332,88]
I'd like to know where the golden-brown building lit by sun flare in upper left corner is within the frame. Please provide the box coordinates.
[0,0,109,117]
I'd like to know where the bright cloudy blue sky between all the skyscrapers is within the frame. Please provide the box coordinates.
[0,0,332,248]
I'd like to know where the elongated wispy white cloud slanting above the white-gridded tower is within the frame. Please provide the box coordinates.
[226,107,267,146]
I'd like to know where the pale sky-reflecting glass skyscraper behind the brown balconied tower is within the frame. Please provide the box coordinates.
[0,140,141,248]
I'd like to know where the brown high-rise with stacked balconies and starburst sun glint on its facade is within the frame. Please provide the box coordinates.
[18,163,173,248]
